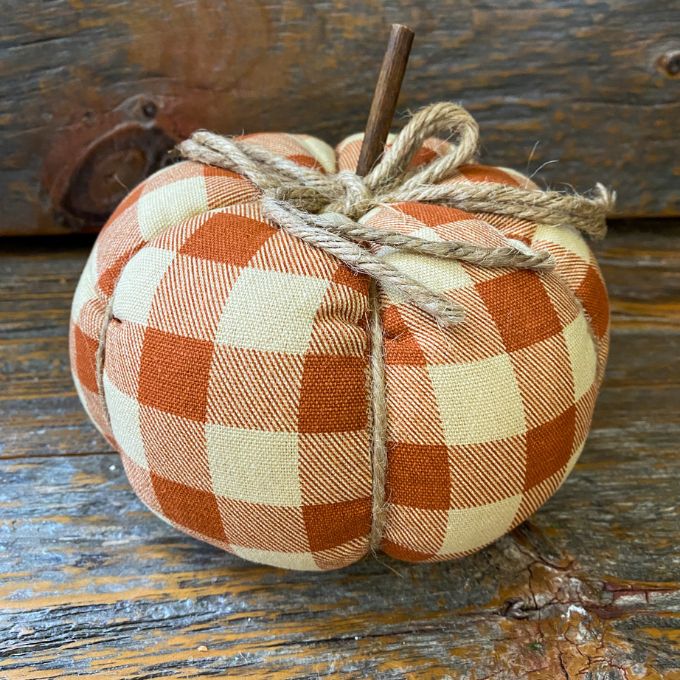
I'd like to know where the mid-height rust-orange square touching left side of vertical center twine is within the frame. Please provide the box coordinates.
[298,355,368,432]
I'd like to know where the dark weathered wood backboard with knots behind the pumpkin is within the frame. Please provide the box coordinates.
[0,0,680,234]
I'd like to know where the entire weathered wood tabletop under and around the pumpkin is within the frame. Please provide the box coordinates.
[0,222,680,680]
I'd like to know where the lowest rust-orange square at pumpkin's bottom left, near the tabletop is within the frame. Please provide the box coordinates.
[151,472,227,541]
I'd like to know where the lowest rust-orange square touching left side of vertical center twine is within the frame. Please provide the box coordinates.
[302,498,371,551]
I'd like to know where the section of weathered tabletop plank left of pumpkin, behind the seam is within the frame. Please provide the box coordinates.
[0,237,100,457]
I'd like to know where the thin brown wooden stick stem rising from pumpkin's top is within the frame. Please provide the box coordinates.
[356,24,414,177]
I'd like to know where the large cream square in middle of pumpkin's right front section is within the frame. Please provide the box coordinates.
[428,354,526,446]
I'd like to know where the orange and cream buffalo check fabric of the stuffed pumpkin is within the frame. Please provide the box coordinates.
[70,129,609,570]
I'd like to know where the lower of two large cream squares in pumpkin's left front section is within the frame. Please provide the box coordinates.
[206,425,302,507]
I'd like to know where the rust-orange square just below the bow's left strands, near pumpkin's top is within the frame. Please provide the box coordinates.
[179,213,276,267]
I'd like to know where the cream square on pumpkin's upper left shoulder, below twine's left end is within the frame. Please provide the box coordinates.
[137,175,208,241]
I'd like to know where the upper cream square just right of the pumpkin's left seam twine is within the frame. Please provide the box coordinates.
[113,246,175,326]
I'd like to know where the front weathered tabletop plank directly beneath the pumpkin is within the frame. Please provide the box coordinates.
[0,454,680,680]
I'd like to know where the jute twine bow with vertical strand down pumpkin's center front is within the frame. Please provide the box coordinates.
[178,102,614,552]
